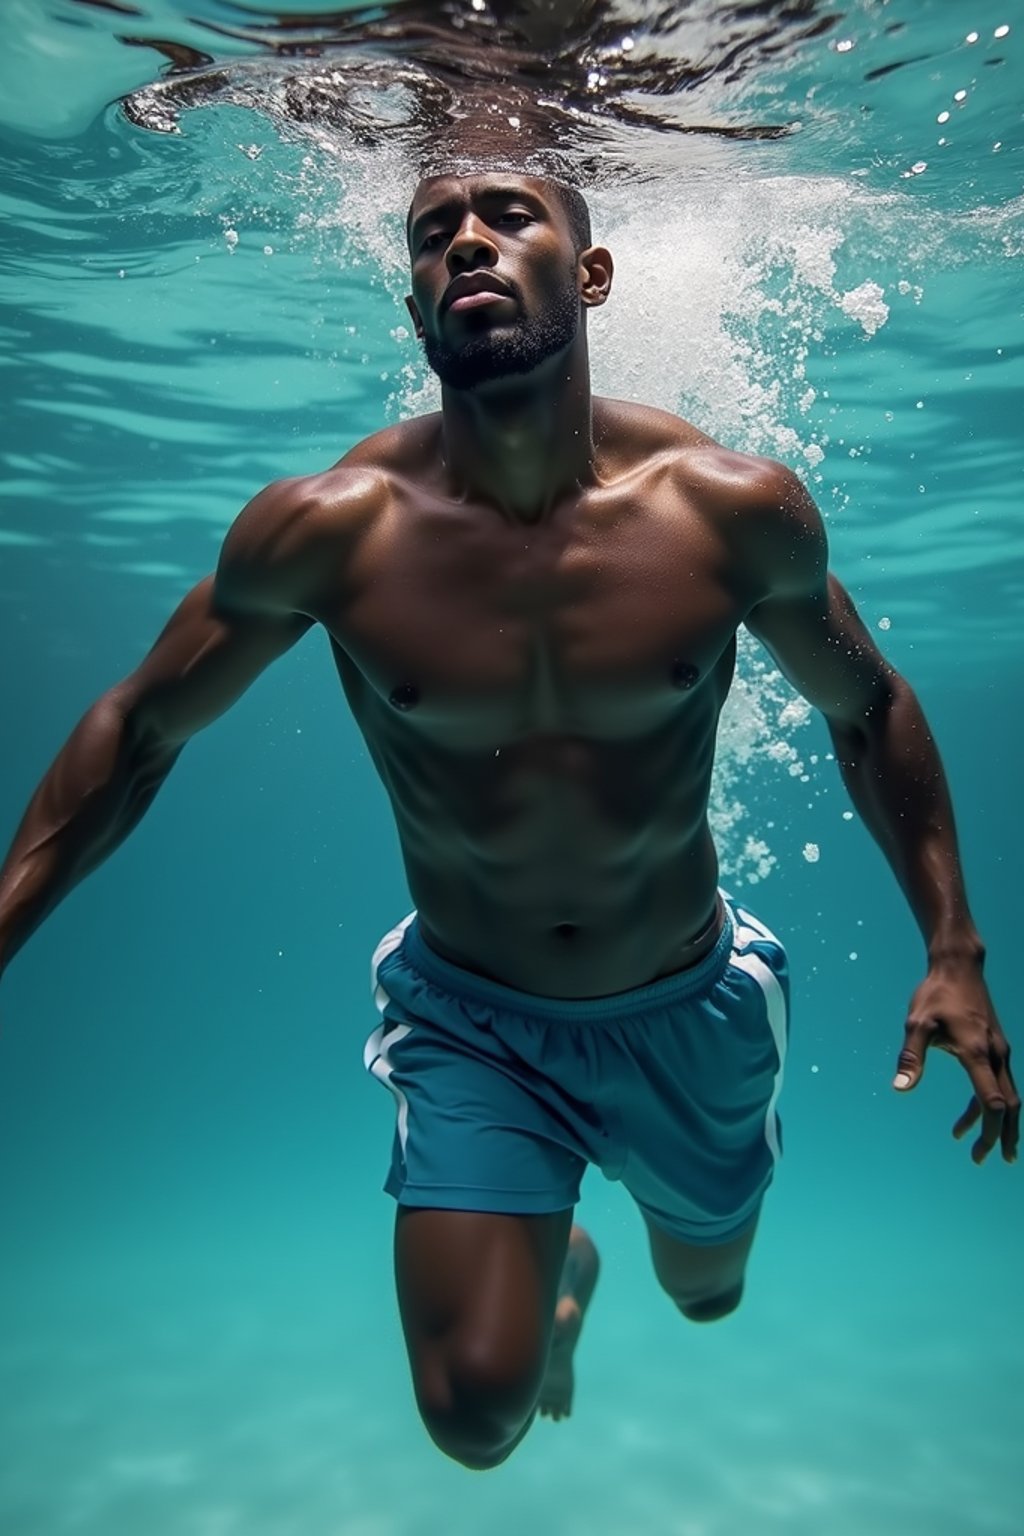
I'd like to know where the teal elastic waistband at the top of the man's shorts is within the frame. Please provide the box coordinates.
[401,895,734,1021]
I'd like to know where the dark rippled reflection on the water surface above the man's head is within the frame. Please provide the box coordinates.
[121,0,837,174]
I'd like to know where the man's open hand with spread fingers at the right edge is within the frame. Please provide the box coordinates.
[892,960,1021,1163]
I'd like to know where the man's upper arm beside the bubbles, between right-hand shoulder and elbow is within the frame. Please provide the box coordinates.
[746,576,897,725]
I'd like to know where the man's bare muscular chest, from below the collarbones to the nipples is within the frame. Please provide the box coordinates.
[325,491,742,736]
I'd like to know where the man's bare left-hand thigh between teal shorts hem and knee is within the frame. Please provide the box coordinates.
[395,1206,573,1412]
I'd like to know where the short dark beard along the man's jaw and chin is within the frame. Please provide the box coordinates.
[424,266,580,390]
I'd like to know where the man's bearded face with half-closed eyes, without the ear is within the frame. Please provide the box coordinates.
[408,174,580,389]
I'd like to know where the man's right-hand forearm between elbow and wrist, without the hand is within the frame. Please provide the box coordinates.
[829,677,984,960]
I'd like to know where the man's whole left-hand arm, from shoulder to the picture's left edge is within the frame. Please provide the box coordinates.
[0,481,316,974]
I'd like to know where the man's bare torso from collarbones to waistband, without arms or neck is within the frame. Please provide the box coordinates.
[315,401,736,997]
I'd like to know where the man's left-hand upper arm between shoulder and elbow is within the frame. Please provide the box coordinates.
[112,576,312,745]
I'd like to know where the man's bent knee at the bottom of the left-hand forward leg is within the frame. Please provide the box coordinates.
[416,1347,542,1471]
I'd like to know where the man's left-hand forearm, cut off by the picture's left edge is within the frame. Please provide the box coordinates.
[0,693,180,972]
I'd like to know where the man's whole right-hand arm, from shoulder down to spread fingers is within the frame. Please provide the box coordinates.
[746,465,1021,1163]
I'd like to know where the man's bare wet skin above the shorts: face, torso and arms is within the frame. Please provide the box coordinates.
[0,174,1019,1130]
